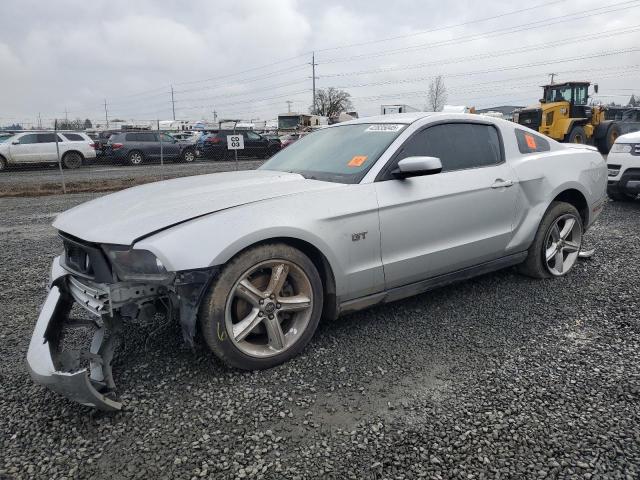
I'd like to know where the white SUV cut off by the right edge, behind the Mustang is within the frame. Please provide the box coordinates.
[607,132,640,201]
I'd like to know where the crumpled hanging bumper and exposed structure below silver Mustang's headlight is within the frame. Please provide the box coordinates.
[27,257,214,411]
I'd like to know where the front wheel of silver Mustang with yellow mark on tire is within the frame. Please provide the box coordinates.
[199,243,323,370]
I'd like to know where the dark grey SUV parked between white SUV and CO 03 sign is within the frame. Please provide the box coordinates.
[107,132,196,165]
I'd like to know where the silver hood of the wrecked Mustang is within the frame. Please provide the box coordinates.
[53,170,341,245]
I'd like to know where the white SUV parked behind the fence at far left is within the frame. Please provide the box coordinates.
[0,132,96,171]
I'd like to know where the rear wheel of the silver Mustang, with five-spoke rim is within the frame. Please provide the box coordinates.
[519,202,583,278]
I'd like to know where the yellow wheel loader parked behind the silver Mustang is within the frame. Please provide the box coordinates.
[514,82,620,154]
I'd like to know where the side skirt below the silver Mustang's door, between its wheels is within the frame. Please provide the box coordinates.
[339,252,527,314]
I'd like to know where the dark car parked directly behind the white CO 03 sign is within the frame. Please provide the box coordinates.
[196,130,281,160]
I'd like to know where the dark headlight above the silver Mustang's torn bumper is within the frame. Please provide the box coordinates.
[102,245,169,281]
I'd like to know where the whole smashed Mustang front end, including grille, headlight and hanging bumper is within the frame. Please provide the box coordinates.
[27,235,216,411]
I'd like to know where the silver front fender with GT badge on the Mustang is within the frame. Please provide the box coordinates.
[135,184,384,300]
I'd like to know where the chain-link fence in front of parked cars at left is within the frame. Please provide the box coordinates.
[0,122,280,197]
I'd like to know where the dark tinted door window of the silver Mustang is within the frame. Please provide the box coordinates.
[398,123,502,172]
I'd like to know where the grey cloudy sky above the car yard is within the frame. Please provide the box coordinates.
[0,0,640,124]
